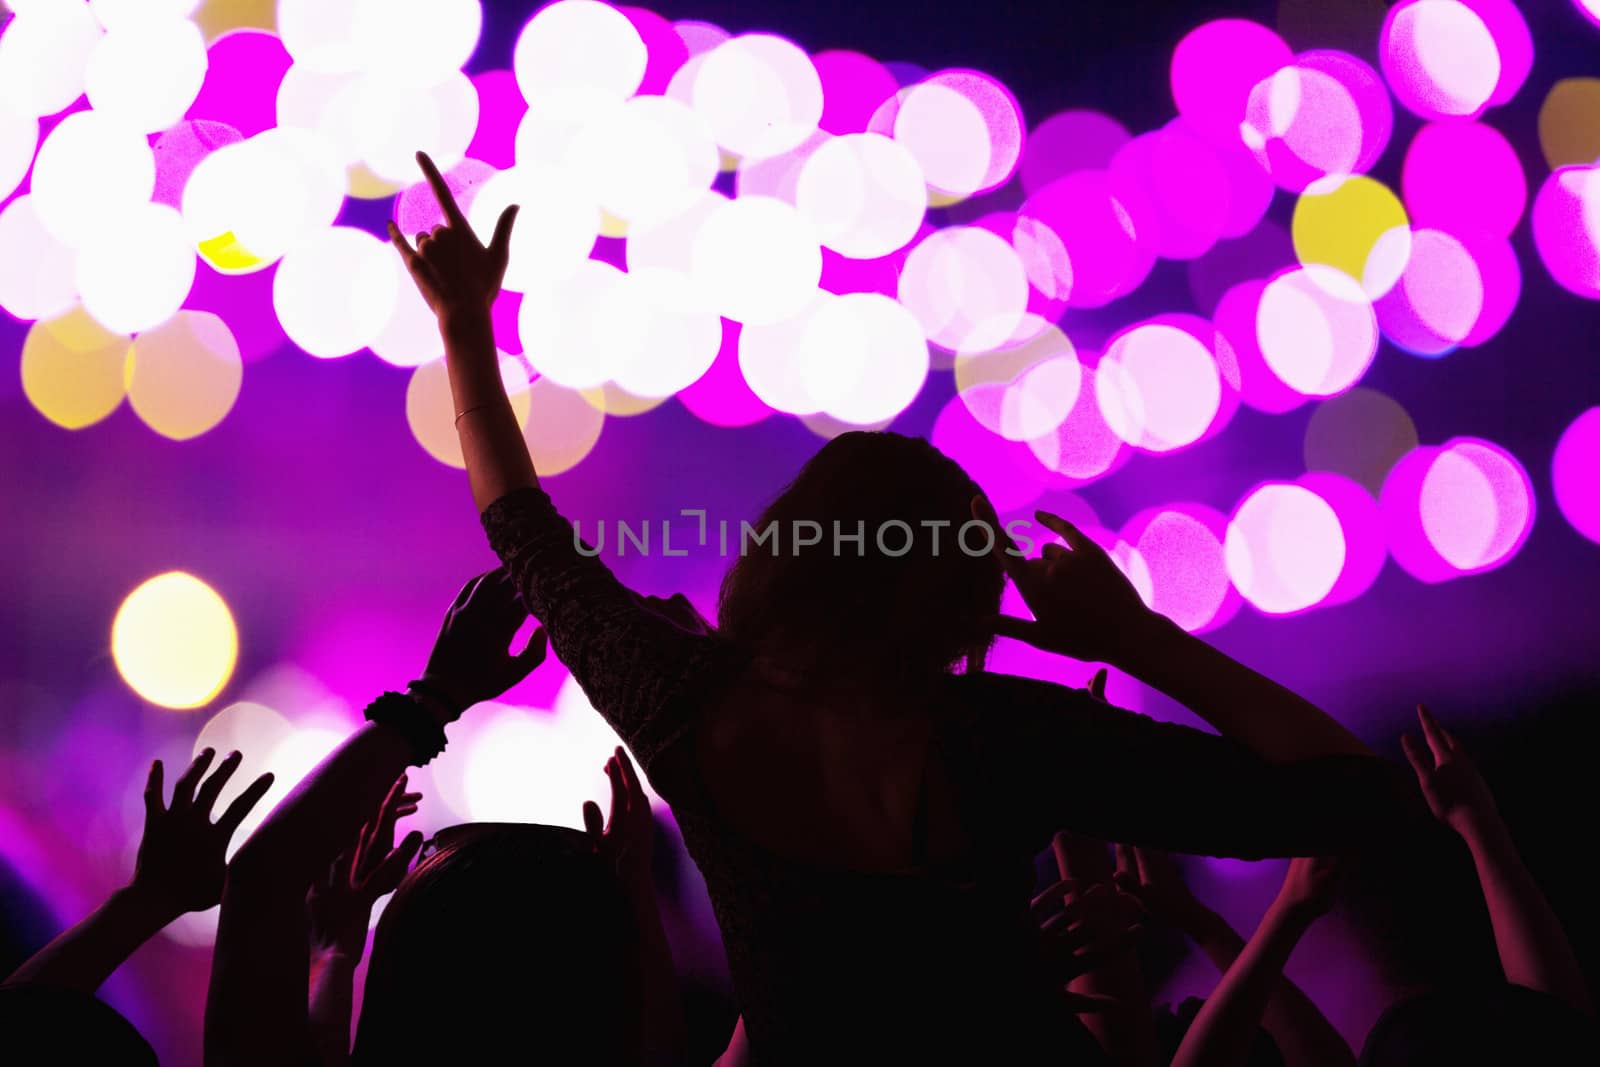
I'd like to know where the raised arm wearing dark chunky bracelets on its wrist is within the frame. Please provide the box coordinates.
[205,571,544,1065]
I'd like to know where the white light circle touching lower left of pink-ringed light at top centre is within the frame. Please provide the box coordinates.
[795,133,928,259]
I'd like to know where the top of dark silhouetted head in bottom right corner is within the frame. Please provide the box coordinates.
[1360,982,1600,1067]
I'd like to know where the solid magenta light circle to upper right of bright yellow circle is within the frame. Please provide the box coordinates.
[1400,122,1528,237]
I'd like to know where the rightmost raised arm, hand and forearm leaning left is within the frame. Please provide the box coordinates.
[1402,705,1594,1016]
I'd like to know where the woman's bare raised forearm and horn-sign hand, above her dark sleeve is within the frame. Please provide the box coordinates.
[389,152,539,512]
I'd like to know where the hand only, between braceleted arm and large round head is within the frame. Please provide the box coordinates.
[306,774,422,960]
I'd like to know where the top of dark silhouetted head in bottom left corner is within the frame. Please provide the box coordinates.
[0,985,158,1067]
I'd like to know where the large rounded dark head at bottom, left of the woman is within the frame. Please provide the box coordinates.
[355,822,640,1064]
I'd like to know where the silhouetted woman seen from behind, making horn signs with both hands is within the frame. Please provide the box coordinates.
[390,157,1427,1064]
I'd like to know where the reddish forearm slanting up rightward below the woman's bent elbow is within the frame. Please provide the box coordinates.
[1173,859,1354,1067]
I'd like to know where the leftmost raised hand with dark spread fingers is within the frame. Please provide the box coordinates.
[128,749,272,918]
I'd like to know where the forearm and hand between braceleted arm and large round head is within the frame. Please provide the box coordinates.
[306,774,422,1064]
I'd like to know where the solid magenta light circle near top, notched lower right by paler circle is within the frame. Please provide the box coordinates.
[1171,19,1294,142]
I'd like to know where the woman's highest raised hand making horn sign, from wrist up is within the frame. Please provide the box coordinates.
[389,152,517,320]
